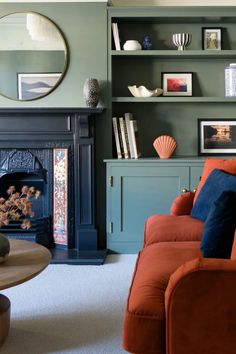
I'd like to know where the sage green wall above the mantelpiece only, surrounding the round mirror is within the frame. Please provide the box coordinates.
[0,2,107,107]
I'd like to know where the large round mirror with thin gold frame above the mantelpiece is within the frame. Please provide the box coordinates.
[0,12,67,101]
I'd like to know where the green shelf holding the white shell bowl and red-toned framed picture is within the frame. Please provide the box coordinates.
[112,96,236,103]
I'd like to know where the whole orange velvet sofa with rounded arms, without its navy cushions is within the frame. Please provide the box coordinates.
[123,159,236,354]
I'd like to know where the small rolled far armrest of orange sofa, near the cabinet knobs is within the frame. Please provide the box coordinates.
[170,192,195,216]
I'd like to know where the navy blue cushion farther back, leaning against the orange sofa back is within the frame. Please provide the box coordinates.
[191,169,236,221]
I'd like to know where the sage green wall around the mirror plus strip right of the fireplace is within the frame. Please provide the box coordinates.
[0,2,111,248]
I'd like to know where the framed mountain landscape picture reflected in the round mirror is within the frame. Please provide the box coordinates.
[17,73,61,100]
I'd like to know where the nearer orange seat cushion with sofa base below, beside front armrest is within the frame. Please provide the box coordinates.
[123,242,200,354]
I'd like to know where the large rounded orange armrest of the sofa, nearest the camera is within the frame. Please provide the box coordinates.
[165,258,236,354]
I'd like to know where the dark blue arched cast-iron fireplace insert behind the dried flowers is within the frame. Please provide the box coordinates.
[0,150,53,248]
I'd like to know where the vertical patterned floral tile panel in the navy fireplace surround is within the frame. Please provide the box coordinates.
[53,149,68,245]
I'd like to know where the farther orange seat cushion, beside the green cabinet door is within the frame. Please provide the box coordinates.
[144,215,203,246]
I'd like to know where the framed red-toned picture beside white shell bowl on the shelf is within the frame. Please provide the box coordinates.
[162,73,192,96]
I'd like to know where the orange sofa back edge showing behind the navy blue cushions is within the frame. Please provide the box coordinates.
[194,158,236,202]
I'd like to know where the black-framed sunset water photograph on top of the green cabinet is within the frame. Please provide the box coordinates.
[198,118,236,155]
